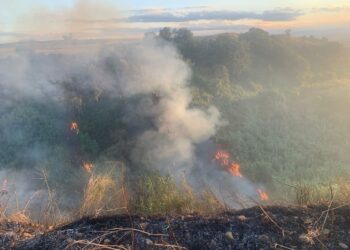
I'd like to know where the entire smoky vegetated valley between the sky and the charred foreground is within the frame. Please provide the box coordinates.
[0,28,350,222]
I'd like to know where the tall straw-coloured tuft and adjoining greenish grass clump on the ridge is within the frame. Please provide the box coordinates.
[78,164,225,217]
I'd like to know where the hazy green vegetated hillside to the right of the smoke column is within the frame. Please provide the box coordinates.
[160,29,350,196]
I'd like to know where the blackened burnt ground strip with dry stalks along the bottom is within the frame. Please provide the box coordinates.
[0,206,350,250]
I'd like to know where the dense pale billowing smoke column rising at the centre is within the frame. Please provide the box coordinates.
[92,42,219,173]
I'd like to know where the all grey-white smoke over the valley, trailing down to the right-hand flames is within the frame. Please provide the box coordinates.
[0,33,274,213]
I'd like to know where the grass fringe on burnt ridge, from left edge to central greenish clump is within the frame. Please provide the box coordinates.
[0,164,226,227]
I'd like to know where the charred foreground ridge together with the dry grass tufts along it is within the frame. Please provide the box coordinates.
[0,164,350,249]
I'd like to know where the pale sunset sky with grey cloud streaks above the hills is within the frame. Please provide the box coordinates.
[0,0,350,43]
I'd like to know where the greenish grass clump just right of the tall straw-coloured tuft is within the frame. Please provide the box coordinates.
[130,173,225,214]
